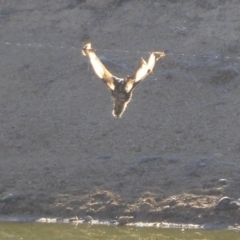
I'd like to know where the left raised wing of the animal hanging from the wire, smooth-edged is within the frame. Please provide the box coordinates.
[82,43,115,90]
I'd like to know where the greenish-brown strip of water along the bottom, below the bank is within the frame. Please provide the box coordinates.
[0,223,240,240]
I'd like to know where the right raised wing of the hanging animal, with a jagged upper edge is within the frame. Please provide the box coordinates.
[125,52,166,92]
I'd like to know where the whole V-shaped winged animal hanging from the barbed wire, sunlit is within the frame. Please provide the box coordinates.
[82,43,166,118]
